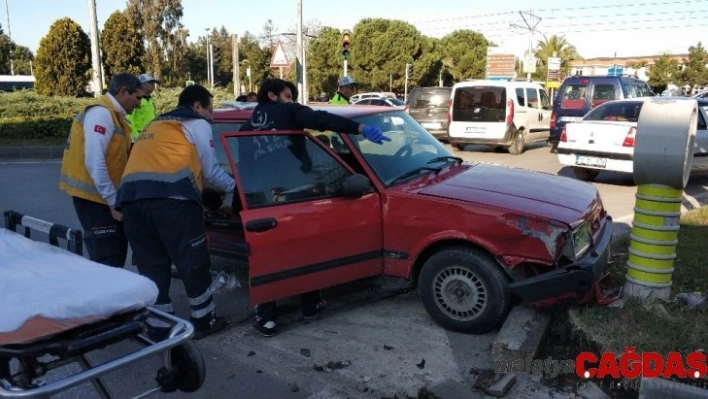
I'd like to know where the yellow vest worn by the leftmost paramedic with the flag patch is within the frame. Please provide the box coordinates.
[59,96,130,205]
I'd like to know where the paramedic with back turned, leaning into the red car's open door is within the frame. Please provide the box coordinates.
[118,85,235,340]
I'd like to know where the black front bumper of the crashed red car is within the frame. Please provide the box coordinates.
[508,216,614,306]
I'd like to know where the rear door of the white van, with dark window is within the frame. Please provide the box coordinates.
[450,84,514,142]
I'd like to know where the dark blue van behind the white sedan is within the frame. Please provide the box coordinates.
[549,76,654,144]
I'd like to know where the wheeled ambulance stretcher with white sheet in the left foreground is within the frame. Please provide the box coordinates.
[0,211,205,398]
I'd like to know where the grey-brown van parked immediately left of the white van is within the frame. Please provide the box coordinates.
[406,87,452,140]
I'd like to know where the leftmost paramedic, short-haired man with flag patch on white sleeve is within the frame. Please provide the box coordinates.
[59,73,143,267]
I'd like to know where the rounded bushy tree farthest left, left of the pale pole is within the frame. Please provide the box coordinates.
[35,18,91,96]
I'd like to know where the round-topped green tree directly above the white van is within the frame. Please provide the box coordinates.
[438,29,490,82]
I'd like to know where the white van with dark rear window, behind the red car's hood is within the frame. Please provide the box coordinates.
[448,80,552,155]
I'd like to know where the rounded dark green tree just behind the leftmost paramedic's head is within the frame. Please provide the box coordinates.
[101,11,145,80]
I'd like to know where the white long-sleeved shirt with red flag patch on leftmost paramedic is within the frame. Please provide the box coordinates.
[84,93,130,206]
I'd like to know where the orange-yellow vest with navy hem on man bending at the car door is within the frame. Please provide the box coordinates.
[116,107,203,204]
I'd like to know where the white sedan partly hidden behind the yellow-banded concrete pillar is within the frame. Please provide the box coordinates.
[558,97,708,181]
